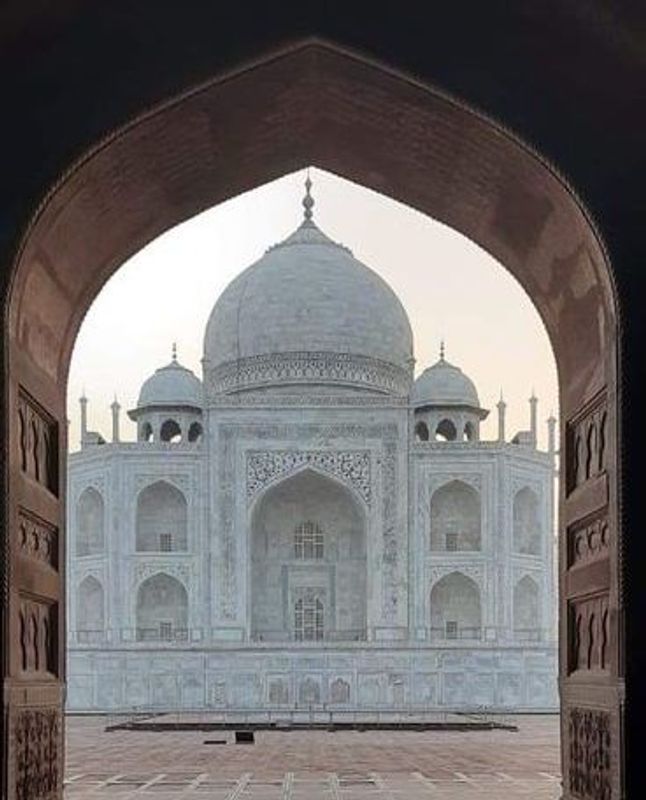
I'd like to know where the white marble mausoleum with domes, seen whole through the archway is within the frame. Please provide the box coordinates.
[68,187,557,711]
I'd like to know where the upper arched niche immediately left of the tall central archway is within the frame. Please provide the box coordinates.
[135,481,188,552]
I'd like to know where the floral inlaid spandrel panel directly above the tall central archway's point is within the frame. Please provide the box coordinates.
[247,450,372,505]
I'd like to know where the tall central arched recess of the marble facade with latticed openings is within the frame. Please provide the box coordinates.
[250,469,367,641]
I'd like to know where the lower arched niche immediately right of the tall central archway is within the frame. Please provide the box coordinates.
[430,572,482,639]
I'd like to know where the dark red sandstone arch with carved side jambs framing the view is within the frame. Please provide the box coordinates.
[3,41,623,798]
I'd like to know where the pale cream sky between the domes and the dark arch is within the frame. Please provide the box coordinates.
[68,169,558,450]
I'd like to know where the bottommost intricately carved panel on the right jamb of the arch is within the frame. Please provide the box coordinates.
[568,708,612,800]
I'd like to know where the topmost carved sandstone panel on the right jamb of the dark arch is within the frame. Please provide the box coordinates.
[565,391,608,493]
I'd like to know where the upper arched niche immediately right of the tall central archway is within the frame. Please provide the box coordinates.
[431,480,482,551]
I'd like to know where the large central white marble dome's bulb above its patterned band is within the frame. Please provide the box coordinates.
[204,208,413,392]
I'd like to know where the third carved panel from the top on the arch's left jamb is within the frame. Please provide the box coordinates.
[18,597,58,675]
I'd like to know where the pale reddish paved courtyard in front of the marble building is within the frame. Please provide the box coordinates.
[65,715,560,800]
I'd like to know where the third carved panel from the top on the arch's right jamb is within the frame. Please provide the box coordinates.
[568,593,610,673]
